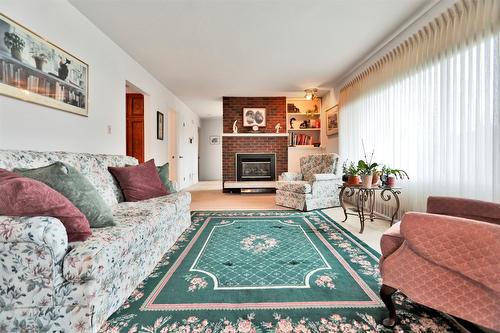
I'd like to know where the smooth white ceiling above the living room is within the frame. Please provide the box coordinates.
[70,0,430,117]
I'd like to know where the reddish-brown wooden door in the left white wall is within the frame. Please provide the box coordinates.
[127,94,144,163]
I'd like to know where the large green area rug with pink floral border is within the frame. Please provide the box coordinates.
[101,211,457,333]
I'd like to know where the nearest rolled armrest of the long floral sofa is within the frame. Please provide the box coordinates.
[0,216,68,312]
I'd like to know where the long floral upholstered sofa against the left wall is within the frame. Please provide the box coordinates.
[0,150,191,332]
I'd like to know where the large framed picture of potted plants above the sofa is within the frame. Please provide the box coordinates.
[0,13,89,116]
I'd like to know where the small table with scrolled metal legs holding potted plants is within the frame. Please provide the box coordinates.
[339,183,401,234]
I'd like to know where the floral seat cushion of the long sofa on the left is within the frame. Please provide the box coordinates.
[63,197,178,285]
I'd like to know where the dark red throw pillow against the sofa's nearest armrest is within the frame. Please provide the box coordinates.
[0,169,92,242]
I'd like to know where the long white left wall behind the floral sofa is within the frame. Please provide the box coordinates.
[0,0,199,185]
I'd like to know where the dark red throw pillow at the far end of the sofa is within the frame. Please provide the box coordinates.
[108,159,169,201]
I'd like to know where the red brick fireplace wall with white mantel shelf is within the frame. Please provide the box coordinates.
[222,97,288,189]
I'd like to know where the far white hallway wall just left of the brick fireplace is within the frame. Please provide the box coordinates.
[200,117,223,180]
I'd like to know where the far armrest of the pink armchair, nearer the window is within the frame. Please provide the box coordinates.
[427,196,500,224]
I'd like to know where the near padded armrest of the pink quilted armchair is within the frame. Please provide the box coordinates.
[401,212,500,292]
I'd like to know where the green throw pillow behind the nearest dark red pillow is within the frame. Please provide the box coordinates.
[14,162,116,228]
